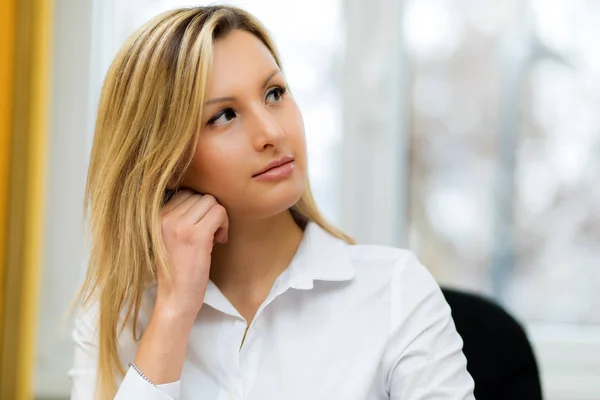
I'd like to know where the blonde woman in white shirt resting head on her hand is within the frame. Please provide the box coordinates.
[70,6,473,400]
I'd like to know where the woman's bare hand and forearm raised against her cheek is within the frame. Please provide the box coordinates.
[130,190,229,384]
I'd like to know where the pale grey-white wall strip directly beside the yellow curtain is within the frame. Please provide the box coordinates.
[34,0,92,398]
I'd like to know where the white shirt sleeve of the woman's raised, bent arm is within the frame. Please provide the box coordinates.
[68,307,180,400]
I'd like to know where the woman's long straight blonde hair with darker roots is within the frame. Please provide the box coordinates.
[77,6,352,398]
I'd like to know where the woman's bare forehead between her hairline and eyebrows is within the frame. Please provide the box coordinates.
[208,30,277,95]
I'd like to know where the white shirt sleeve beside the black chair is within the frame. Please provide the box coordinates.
[384,253,475,400]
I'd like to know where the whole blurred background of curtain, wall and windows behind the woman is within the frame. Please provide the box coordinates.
[0,0,600,400]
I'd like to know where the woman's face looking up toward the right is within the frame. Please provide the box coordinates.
[182,30,307,219]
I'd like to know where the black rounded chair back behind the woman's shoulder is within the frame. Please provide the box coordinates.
[442,288,542,400]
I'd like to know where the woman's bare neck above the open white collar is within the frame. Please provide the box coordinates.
[210,211,303,305]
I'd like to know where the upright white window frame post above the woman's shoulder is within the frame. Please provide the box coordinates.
[340,0,410,247]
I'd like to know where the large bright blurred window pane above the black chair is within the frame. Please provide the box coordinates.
[404,0,600,324]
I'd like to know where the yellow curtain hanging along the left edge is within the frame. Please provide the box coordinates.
[0,0,52,400]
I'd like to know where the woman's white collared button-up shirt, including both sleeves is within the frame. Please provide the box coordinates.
[69,223,474,400]
